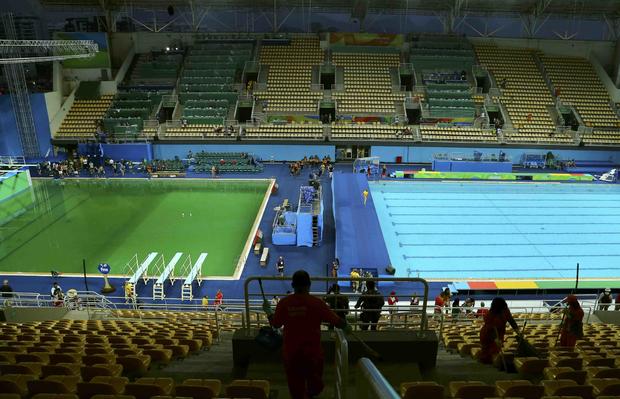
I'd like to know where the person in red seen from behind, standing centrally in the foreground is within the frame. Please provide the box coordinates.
[263,270,351,399]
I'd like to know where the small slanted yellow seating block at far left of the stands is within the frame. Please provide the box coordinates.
[55,95,113,139]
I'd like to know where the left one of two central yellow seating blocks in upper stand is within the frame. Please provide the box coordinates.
[254,37,324,113]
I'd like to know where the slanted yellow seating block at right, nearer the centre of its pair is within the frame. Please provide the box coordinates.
[475,46,573,144]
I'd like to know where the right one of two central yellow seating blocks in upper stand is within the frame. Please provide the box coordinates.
[332,53,404,115]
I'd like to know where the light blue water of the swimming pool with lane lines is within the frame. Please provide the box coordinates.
[369,181,620,279]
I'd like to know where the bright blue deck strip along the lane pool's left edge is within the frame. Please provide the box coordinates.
[333,173,390,274]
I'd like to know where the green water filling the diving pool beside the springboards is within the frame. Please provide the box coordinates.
[0,179,268,276]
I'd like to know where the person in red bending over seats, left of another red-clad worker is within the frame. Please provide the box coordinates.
[478,298,520,363]
